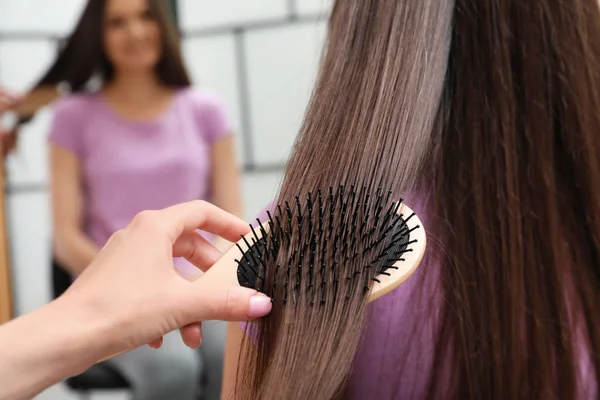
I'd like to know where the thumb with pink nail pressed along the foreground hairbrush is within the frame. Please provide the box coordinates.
[185,286,272,321]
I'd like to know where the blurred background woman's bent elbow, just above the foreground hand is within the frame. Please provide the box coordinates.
[54,231,100,275]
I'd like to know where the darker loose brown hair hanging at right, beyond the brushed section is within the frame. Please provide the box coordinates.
[425,0,600,399]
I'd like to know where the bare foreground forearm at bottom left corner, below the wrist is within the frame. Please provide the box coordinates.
[0,299,110,400]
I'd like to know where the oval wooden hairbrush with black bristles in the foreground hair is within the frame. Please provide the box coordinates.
[207,185,426,305]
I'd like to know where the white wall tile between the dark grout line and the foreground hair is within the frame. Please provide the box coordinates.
[246,22,325,164]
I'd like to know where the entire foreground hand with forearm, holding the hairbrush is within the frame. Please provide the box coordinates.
[0,201,271,400]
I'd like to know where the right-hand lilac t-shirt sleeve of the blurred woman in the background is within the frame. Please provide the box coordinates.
[190,89,232,143]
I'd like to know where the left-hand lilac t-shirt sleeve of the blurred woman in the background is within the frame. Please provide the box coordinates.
[48,96,86,158]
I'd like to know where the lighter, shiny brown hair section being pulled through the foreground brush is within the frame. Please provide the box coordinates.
[236,0,452,399]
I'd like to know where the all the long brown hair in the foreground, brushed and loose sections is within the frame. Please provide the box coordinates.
[235,0,600,399]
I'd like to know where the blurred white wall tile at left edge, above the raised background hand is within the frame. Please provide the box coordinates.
[0,40,57,91]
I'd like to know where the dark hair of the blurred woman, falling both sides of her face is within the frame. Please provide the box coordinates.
[36,0,190,92]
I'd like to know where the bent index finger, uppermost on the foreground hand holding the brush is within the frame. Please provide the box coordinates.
[159,200,250,243]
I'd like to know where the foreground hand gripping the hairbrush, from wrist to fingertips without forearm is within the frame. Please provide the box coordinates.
[59,201,271,356]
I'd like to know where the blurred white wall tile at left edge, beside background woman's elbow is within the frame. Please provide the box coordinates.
[7,192,51,315]
